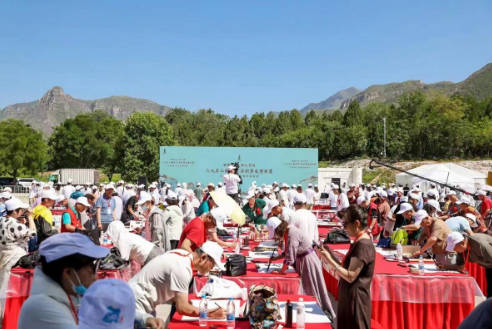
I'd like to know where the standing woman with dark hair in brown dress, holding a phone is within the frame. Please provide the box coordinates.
[320,205,376,329]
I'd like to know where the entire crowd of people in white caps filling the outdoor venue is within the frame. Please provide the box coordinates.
[0,167,492,329]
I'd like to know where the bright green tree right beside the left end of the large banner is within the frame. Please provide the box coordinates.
[116,112,175,181]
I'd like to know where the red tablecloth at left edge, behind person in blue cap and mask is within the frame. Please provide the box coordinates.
[2,267,128,329]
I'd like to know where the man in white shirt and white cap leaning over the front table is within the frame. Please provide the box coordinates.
[128,241,225,320]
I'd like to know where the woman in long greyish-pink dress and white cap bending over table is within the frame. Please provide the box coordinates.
[273,222,335,319]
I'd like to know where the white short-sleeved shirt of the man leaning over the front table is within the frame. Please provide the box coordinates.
[128,249,193,315]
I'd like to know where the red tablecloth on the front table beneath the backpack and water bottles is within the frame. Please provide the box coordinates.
[168,294,331,329]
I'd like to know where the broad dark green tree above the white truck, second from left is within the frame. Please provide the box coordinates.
[48,111,123,176]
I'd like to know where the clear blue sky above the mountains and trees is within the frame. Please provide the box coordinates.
[0,0,492,115]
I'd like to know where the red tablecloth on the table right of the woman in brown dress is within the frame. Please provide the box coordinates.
[324,241,481,329]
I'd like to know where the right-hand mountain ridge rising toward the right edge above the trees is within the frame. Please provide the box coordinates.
[301,63,492,114]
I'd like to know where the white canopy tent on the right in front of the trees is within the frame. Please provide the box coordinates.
[396,163,487,193]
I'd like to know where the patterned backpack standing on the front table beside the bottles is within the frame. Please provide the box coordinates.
[248,285,281,329]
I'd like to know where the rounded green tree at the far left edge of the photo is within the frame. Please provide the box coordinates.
[0,119,48,178]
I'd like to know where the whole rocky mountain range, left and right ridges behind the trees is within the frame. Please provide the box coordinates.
[0,63,492,135]
